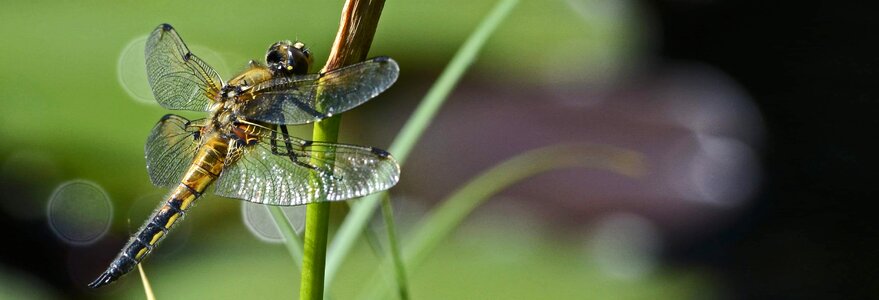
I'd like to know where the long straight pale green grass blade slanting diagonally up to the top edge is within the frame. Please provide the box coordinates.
[326,0,518,288]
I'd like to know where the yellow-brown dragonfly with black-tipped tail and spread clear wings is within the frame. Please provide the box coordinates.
[89,24,400,288]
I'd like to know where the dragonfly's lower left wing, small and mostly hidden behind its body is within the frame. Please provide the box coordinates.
[145,114,205,187]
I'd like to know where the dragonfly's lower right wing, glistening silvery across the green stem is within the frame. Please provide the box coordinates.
[214,125,400,205]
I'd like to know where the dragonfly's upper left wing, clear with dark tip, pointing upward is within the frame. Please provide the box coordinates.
[145,24,223,111]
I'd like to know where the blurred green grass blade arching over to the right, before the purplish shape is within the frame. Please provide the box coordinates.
[366,145,646,299]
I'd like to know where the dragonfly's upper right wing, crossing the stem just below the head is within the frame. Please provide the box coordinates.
[242,57,400,125]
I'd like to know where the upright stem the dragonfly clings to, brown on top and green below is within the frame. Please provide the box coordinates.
[299,0,384,300]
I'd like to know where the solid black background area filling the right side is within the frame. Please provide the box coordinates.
[650,1,879,299]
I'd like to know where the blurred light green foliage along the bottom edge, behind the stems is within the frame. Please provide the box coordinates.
[107,223,711,299]
